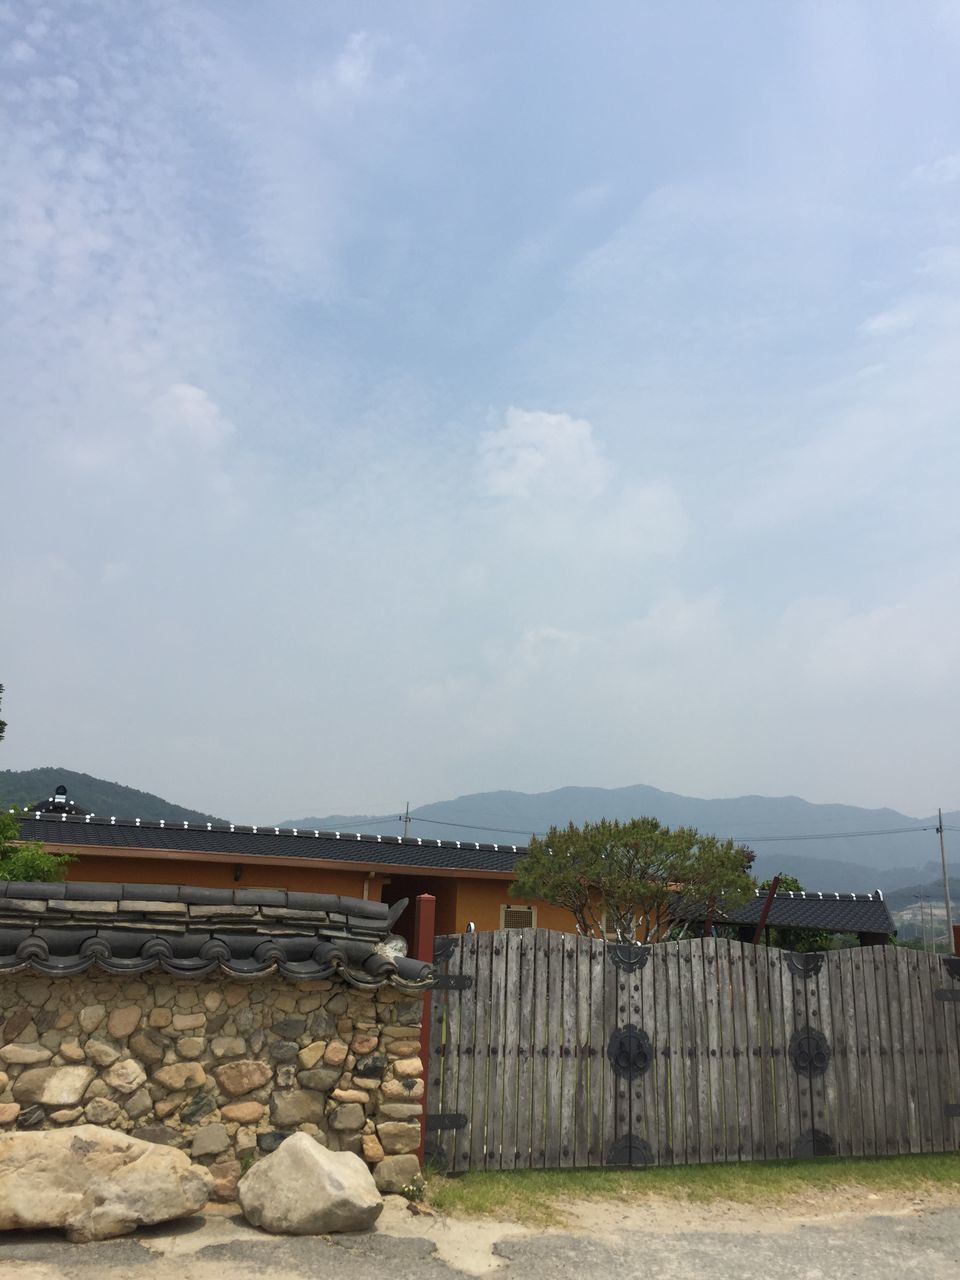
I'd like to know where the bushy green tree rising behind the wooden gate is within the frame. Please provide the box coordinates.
[511,818,753,942]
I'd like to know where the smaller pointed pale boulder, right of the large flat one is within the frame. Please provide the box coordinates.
[238,1133,383,1235]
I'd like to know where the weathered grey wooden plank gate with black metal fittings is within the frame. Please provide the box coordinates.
[426,929,960,1171]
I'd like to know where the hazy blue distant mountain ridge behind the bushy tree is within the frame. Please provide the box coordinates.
[282,785,960,893]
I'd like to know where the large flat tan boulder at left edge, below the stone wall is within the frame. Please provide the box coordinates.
[0,1124,212,1243]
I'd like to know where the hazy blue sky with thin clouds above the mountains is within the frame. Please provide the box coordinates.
[0,0,960,822]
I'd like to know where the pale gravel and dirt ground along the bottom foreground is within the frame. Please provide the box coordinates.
[0,1203,960,1280]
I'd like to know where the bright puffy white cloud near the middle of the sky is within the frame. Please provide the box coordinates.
[480,408,611,500]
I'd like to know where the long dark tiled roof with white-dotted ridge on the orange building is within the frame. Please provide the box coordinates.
[20,812,525,873]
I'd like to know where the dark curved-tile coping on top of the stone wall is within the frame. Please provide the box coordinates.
[0,881,433,991]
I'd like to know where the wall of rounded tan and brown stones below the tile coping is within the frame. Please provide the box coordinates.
[0,970,424,1199]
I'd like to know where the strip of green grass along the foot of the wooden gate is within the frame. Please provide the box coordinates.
[428,1153,960,1226]
